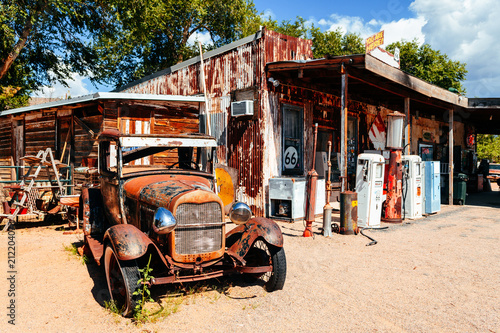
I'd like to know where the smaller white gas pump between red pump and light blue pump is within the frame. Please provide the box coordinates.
[402,155,424,219]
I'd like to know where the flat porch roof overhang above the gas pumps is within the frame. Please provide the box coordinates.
[266,54,468,112]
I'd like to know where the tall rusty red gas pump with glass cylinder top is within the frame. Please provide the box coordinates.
[382,111,405,223]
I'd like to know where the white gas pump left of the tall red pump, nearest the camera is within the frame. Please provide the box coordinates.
[356,154,385,228]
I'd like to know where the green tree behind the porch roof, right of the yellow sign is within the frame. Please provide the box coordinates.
[387,39,467,94]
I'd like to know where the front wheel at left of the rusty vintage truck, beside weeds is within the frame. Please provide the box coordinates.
[104,244,141,317]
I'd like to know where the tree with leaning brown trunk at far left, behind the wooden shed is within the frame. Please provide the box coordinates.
[0,0,102,109]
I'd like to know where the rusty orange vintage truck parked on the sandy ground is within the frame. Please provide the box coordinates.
[80,130,286,316]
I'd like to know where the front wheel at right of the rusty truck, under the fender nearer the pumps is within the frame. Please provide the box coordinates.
[245,239,286,292]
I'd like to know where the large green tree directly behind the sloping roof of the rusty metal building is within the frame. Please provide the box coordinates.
[94,0,259,86]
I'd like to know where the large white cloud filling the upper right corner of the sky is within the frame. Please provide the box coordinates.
[410,0,500,97]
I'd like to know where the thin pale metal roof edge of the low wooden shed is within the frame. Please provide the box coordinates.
[0,92,205,117]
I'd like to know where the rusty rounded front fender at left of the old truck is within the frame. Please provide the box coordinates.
[104,224,153,260]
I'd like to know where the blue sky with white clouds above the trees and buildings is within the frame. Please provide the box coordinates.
[35,0,500,97]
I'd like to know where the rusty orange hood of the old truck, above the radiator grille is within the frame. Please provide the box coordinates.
[123,175,221,212]
